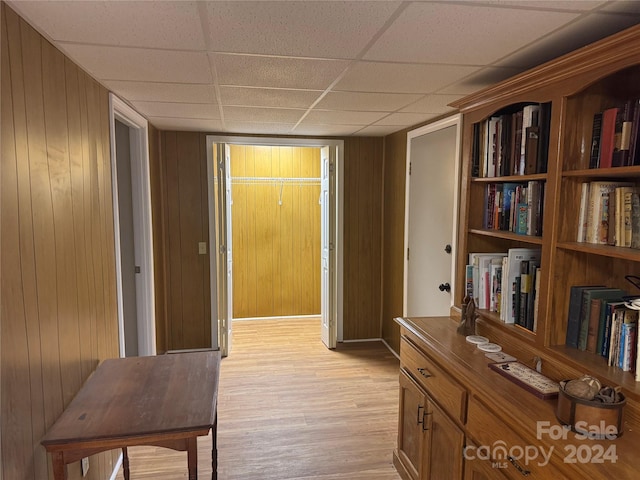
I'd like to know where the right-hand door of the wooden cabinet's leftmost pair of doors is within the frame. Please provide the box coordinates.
[423,402,464,480]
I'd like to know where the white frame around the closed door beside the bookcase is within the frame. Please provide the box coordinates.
[402,114,462,317]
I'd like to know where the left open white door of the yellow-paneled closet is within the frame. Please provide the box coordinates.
[214,143,233,356]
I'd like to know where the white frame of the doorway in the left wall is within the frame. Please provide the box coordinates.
[109,93,156,357]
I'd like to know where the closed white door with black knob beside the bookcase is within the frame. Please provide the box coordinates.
[404,119,459,316]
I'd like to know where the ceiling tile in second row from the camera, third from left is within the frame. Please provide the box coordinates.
[335,62,478,94]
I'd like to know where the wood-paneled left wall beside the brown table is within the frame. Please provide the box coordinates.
[0,3,118,480]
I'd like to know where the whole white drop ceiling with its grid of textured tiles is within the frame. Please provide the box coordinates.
[8,0,640,136]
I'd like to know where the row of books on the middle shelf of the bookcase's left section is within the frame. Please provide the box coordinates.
[483,181,545,235]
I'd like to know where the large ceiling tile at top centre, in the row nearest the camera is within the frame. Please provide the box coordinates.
[206,1,401,58]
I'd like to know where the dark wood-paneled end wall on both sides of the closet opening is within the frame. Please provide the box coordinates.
[152,135,383,349]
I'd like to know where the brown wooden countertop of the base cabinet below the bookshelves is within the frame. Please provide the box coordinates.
[396,317,640,479]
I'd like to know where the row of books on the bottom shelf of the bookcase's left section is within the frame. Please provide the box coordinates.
[466,248,541,332]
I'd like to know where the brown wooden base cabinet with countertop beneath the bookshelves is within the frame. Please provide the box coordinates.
[394,317,640,480]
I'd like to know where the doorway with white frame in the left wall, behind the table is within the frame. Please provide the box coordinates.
[109,94,156,357]
